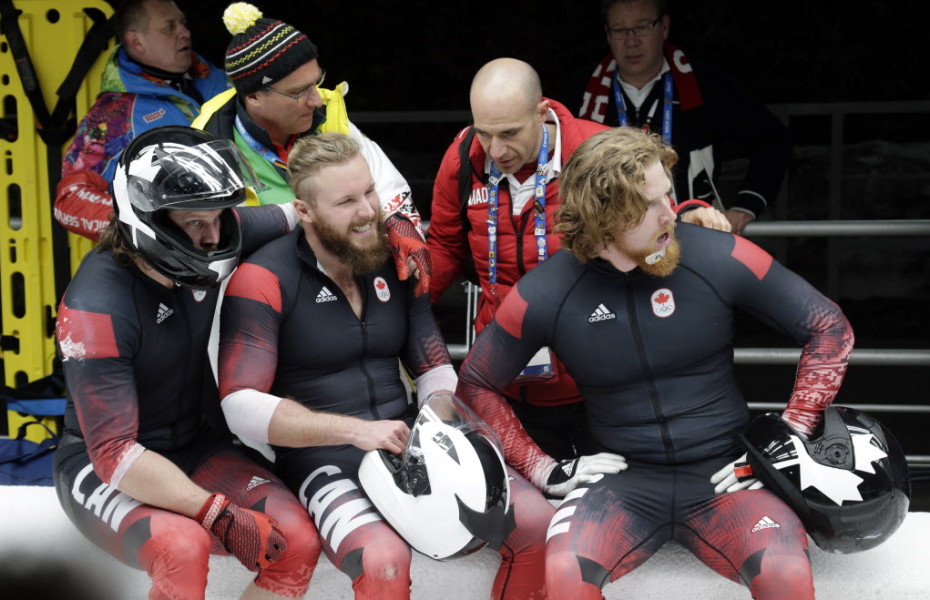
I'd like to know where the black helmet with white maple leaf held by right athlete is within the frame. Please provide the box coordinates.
[742,406,911,554]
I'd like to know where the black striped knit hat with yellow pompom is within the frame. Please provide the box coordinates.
[223,2,319,95]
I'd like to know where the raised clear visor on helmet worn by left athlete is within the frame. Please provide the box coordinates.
[127,140,262,212]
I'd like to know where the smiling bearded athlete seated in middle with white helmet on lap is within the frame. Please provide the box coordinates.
[220,133,553,600]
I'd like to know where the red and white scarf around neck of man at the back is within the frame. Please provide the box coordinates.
[578,43,704,123]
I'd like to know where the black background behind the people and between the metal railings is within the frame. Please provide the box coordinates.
[180,0,930,496]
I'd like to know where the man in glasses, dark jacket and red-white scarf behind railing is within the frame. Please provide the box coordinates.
[579,0,791,234]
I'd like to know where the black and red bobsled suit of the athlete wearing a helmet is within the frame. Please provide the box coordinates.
[54,206,320,599]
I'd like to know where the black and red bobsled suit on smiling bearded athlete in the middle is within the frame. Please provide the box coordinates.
[220,231,552,600]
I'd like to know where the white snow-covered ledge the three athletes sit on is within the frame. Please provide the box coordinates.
[0,486,930,600]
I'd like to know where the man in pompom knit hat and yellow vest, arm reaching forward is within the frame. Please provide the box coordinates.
[193,2,430,293]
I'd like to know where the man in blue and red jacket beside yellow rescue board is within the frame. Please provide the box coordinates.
[55,0,229,242]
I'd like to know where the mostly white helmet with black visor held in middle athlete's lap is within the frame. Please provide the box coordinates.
[358,395,515,560]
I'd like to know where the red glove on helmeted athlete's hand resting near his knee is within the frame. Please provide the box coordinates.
[196,494,287,571]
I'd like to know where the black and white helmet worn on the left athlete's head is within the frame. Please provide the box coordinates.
[113,125,259,289]
